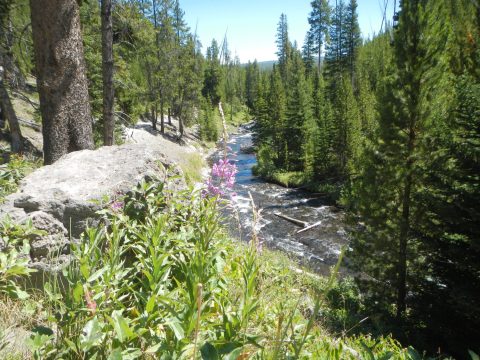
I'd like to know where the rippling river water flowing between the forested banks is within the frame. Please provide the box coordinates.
[212,125,348,274]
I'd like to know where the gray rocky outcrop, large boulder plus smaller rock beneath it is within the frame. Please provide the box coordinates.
[0,144,185,278]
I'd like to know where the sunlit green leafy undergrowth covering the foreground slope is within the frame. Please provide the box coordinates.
[0,178,450,359]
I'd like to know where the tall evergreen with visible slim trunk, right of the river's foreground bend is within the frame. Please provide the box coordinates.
[346,0,428,318]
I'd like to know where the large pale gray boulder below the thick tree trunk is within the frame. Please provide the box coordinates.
[6,144,183,238]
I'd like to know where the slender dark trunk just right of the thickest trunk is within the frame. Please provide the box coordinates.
[102,0,115,146]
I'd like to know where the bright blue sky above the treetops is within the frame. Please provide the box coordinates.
[180,0,394,62]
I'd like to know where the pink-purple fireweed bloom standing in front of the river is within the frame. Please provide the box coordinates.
[204,159,237,197]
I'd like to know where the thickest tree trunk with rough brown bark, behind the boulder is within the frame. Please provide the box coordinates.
[30,0,94,164]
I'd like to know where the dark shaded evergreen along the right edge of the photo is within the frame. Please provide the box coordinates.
[411,1,480,358]
